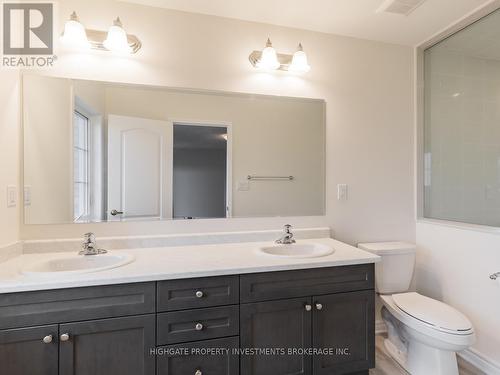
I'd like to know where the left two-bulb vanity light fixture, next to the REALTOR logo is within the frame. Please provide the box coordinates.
[61,12,142,54]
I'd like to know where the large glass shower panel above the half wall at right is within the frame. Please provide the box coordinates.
[423,11,500,227]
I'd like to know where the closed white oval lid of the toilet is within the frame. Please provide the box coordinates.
[392,293,472,333]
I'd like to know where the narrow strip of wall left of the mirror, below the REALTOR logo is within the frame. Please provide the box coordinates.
[0,70,21,250]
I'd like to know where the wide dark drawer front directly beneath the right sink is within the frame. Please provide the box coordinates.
[240,264,374,303]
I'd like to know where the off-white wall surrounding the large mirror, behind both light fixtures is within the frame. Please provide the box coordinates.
[16,0,415,243]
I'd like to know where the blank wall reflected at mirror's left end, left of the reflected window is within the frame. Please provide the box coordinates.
[23,75,73,224]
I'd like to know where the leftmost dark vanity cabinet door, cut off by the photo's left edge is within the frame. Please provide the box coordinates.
[0,325,58,375]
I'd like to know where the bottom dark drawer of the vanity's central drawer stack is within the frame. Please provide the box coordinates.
[156,337,240,375]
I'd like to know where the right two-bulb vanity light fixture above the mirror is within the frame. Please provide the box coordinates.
[252,38,311,73]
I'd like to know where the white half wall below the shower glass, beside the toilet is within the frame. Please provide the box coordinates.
[416,222,500,368]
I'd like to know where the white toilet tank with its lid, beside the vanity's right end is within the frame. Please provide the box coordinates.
[358,242,416,294]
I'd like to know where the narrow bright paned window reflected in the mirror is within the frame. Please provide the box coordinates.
[73,111,90,222]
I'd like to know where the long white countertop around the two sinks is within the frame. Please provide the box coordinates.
[0,238,380,293]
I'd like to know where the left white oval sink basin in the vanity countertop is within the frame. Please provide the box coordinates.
[22,254,135,275]
